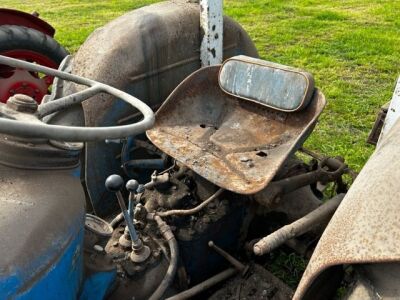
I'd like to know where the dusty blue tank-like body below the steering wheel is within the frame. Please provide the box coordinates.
[0,135,85,299]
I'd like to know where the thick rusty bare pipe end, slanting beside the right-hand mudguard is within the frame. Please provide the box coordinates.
[253,194,345,255]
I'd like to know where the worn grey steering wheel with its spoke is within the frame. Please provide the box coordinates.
[0,55,154,142]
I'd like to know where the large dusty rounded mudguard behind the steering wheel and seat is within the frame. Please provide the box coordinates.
[73,1,258,216]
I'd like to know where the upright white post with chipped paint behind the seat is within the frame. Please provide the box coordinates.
[200,0,223,67]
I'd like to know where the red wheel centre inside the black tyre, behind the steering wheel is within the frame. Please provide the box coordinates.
[0,50,58,103]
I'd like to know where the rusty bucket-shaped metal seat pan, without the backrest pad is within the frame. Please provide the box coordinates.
[147,66,325,194]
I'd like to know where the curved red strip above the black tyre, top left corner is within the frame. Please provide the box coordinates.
[0,8,56,37]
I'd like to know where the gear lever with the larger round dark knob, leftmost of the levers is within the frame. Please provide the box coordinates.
[105,174,150,263]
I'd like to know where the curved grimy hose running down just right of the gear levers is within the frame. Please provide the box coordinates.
[149,214,179,300]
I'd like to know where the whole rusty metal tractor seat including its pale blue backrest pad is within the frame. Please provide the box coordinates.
[147,56,325,194]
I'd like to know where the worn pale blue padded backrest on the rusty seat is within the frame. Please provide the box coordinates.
[218,55,314,112]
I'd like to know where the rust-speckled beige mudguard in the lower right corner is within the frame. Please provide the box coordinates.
[295,121,400,299]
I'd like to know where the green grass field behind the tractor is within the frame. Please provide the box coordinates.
[1,0,400,170]
